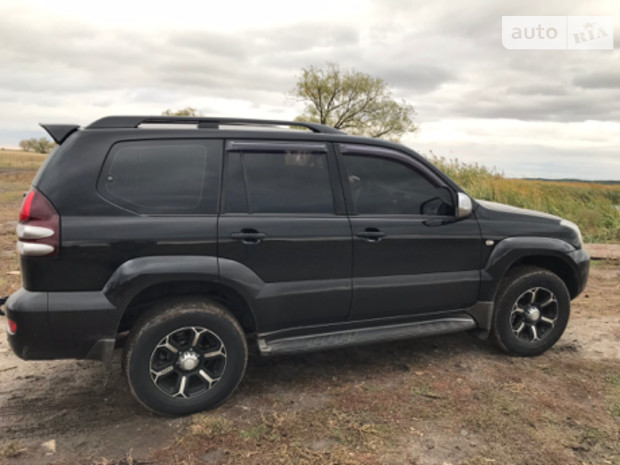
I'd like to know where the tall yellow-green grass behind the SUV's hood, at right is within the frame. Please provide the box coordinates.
[429,155,620,243]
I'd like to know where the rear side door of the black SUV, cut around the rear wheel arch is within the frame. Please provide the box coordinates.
[218,141,351,332]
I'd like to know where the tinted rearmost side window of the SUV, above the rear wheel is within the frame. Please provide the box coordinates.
[98,140,221,214]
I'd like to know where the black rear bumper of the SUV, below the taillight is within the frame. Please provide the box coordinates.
[6,289,118,360]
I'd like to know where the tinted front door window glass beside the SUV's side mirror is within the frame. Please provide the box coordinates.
[343,155,454,215]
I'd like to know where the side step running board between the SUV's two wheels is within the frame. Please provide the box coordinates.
[258,316,477,355]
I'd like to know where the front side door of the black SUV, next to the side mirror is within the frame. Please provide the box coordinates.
[339,145,481,320]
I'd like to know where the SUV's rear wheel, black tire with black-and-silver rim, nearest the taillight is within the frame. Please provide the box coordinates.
[124,297,248,415]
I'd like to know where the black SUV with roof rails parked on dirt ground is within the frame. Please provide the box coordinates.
[6,116,589,414]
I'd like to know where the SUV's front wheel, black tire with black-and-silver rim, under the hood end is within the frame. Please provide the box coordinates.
[491,266,570,357]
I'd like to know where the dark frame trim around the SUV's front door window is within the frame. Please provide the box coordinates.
[335,144,456,219]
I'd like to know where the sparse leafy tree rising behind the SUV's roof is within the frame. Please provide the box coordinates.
[292,63,417,140]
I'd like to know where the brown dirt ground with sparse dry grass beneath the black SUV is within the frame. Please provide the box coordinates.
[0,260,620,465]
